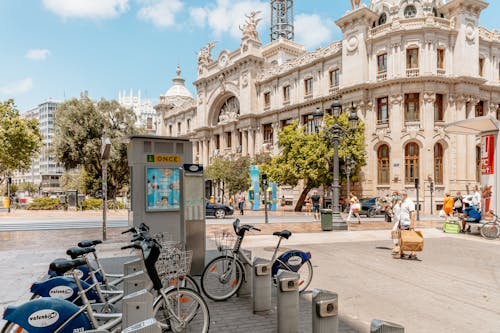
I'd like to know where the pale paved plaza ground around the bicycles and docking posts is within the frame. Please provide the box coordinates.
[0,214,500,333]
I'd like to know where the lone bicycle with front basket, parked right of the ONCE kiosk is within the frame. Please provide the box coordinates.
[201,219,313,301]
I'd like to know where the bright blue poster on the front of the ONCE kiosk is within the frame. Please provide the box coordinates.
[146,168,180,211]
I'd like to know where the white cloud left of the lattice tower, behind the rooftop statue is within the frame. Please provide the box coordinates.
[190,0,269,38]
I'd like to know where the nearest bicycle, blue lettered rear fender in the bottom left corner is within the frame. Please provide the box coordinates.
[1,235,210,333]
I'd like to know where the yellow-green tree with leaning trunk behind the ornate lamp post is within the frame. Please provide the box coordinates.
[262,113,366,211]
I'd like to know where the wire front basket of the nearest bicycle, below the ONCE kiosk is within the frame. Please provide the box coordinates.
[156,248,193,279]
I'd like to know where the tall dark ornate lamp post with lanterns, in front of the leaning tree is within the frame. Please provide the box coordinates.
[325,100,359,230]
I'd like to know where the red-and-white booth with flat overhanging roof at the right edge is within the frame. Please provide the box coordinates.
[445,115,500,216]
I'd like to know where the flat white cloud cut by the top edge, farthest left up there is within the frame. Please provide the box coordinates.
[43,0,129,19]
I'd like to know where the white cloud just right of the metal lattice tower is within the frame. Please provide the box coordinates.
[295,14,338,49]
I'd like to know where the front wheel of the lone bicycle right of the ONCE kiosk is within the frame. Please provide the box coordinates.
[201,256,243,301]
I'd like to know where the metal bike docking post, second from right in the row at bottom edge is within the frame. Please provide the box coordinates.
[312,289,339,333]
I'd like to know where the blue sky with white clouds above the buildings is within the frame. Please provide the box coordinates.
[0,0,500,111]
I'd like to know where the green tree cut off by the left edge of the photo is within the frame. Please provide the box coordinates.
[0,99,41,183]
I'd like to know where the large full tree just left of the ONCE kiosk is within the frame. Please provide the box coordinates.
[54,96,136,198]
